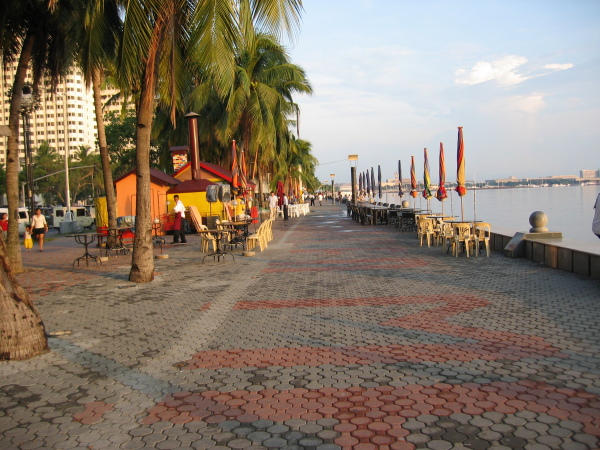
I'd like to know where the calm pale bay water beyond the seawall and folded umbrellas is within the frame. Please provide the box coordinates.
[376,185,600,246]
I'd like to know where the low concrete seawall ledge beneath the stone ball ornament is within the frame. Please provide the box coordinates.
[490,231,600,279]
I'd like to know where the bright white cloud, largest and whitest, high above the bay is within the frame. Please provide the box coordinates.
[455,55,529,86]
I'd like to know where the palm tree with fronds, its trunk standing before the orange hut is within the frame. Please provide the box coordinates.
[117,0,301,282]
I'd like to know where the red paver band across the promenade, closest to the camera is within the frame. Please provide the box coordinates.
[142,381,600,447]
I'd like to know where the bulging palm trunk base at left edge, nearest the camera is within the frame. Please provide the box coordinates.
[0,239,48,361]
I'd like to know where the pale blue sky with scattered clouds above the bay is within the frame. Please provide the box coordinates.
[288,0,600,183]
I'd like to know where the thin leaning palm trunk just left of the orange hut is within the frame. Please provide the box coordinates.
[92,68,117,232]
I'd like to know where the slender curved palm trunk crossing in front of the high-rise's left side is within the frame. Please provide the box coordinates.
[6,35,35,273]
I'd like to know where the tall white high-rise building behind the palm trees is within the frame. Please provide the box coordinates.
[0,63,97,165]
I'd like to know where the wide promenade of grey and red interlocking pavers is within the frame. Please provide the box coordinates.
[0,205,600,450]
